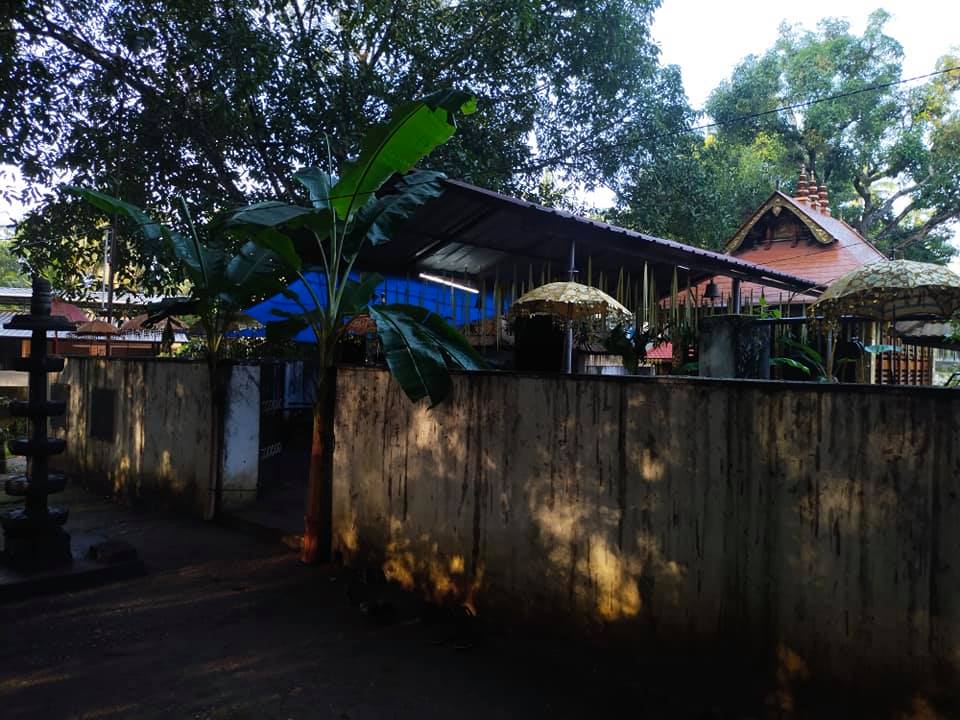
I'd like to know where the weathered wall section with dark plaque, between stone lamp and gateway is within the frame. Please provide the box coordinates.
[56,358,210,515]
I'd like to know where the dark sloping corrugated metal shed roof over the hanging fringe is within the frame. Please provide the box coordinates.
[360,180,817,292]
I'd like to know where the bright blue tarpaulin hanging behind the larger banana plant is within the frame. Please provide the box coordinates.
[239,272,502,342]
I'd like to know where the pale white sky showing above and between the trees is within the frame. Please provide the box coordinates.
[0,0,960,271]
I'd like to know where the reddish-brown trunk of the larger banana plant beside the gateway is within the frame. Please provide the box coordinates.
[308,367,337,564]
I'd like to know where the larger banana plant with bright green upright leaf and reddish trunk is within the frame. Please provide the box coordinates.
[222,90,483,562]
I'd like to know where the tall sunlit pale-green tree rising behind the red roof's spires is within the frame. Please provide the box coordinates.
[707,10,960,262]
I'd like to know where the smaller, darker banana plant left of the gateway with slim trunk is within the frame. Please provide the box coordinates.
[67,187,296,518]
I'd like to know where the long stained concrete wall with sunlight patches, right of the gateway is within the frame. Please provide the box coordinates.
[333,368,960,682]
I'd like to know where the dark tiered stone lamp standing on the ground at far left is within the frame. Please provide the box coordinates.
[0,277,76,572]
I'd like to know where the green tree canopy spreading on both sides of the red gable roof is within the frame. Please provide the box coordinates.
[621,11,960,262]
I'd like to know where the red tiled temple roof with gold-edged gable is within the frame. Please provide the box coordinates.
[698,191,886,304]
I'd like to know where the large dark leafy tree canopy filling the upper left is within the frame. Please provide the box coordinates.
[0,0,686,290]
